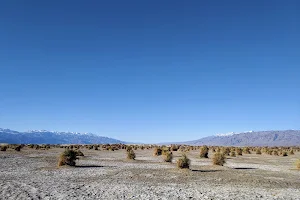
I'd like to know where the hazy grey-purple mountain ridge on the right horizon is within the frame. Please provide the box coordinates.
[181,130,300,146]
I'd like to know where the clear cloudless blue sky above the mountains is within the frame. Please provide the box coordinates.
[0,0,300,143]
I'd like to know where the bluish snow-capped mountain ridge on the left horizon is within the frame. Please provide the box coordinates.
[0,128,127,144]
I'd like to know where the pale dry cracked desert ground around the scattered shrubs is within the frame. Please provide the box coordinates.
[0,148,300,200]
